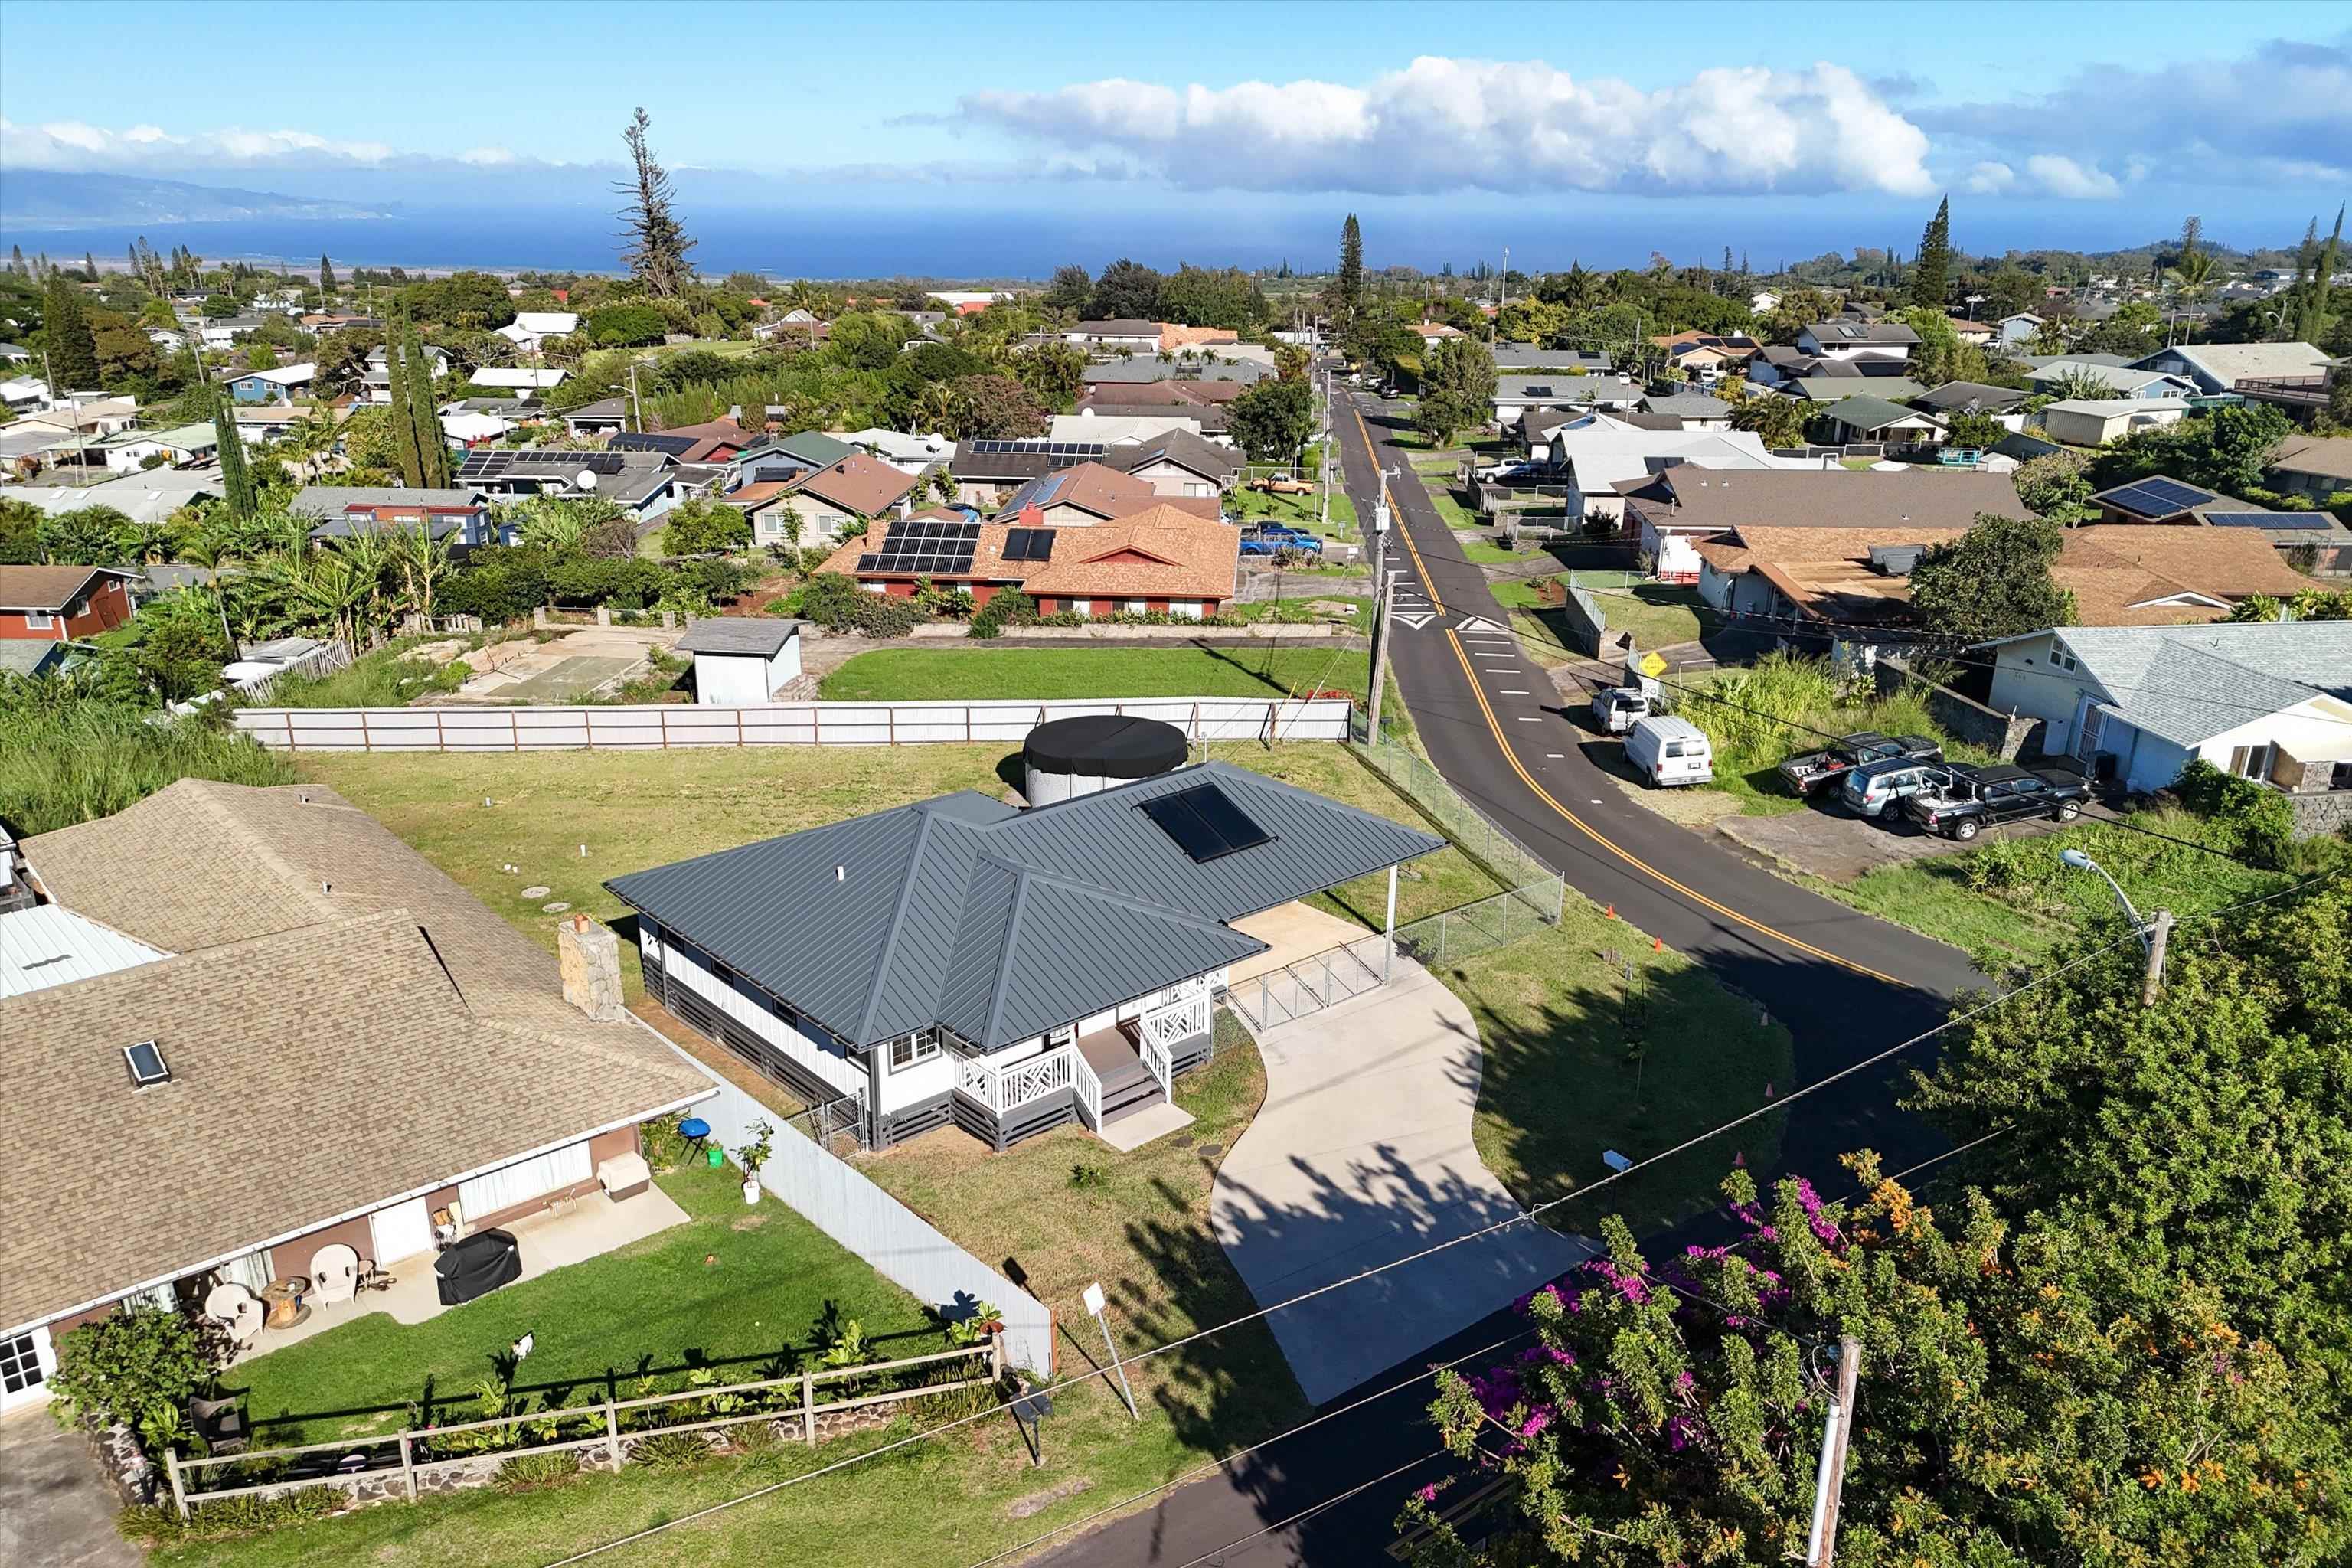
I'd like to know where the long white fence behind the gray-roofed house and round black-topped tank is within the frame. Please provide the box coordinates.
[235,696,1352,753]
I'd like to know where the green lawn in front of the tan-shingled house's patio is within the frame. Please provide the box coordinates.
[224,1161,943,1448]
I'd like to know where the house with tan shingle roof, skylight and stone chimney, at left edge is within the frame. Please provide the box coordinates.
[0,778,713,1406]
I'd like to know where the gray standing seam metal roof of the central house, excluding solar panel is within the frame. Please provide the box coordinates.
[607,762,1444,1050]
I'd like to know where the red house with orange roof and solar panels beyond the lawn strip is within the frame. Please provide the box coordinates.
[823,501,1242,621]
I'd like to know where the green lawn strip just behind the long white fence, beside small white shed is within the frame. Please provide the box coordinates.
[818,646,1369,703]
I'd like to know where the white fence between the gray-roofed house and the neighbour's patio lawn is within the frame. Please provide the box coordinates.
[644,1041,1054,1377]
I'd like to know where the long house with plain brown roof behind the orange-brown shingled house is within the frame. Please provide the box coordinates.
[1615,472,2018,583]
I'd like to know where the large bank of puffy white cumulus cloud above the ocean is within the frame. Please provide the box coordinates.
[959,57,1936,195]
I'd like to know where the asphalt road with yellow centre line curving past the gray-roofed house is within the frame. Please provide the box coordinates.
[1044,400,1983,1568]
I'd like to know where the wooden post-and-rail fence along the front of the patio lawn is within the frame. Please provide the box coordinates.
[165,1335,1004,1519]
